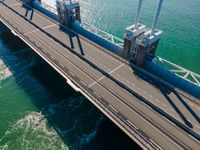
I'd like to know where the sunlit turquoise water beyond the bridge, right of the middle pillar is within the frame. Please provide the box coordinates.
[80,0,200,74]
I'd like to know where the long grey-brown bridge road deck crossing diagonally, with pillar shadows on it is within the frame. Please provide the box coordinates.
[0,0,200,150]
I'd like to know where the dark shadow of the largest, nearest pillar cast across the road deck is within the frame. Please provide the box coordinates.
[132,66,200,128]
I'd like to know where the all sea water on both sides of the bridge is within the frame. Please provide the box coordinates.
[0,0,200,150]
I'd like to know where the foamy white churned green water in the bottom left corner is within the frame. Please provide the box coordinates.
[0,112,68,150]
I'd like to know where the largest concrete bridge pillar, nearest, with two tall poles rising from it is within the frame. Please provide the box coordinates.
[122,0,163,66]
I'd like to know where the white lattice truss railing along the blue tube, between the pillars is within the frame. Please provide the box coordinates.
[41,2,200,86]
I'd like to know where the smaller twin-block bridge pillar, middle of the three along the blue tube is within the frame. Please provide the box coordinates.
[56,0,81,27]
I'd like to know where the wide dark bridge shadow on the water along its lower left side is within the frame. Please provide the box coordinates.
[0,29,140,150]
